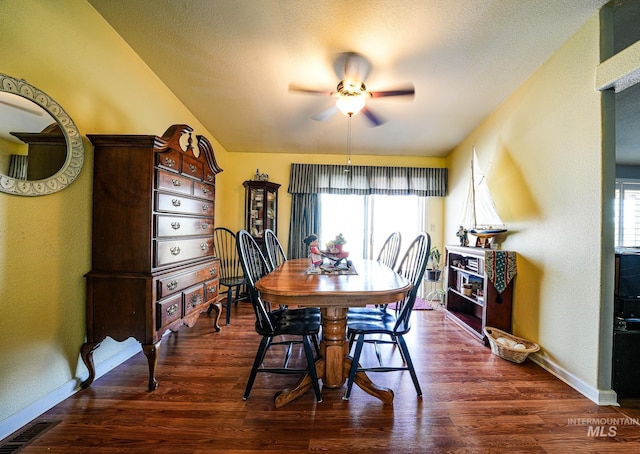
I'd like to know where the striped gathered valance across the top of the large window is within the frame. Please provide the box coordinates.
[289,164,447,197]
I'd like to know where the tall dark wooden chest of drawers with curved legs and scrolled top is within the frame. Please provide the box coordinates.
[81,125,222,390]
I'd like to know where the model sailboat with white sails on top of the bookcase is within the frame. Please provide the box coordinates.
[462,147,507,248]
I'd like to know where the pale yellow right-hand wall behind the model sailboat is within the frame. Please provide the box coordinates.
[445,15,613,398]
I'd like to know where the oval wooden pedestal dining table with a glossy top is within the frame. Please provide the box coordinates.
[256,259,412,407]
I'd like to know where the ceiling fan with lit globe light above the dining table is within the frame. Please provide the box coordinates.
[289,52,415,126]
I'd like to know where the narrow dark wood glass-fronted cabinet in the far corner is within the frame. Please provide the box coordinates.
[242,180,280,247]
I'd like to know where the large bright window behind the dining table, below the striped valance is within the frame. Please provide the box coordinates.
[318,194,427,260]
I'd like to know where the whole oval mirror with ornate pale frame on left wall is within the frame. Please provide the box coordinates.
[0,74,84,196]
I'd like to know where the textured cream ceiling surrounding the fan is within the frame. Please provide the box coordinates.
[89,0,606,156]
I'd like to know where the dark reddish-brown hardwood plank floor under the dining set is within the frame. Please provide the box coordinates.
[7,303,640,454]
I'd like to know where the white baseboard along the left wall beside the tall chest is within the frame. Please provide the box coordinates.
[0,343,141,440]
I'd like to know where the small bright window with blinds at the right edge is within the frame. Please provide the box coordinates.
[615,180,640,247]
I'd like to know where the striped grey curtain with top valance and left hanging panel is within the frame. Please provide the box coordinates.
[288,164,447,258]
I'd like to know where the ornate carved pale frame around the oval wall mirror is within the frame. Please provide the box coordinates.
[0,74,84,196]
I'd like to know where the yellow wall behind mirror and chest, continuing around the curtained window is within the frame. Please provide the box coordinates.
[0,0,444,430]
